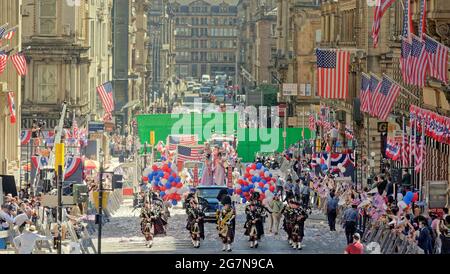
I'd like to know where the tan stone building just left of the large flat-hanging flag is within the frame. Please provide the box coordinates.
[272,0,322,128]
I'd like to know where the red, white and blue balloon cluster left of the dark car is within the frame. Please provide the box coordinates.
[142,162,189,205]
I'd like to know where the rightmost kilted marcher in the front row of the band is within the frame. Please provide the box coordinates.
[281,199,308,250]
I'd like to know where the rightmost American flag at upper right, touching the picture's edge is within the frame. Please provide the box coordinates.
[424,34,448,84]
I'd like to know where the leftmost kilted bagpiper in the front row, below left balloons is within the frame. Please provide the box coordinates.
[140,195,167,248]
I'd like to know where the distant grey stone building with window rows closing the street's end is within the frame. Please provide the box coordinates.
[170,0,238,78]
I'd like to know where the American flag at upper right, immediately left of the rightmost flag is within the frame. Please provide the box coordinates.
[408,35,428,87]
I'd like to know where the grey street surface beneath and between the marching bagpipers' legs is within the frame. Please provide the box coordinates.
[93,200,346,254]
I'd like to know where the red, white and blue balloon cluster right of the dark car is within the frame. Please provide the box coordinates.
[234,163,276,204]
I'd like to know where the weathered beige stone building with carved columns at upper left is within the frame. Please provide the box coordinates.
[22,0,112,128]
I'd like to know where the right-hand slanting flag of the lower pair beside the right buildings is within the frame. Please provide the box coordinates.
[376,76,400,121]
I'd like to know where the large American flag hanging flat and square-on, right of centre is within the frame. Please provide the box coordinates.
[316,49,350,99]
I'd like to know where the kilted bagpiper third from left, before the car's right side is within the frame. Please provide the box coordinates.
[216,196,236,252]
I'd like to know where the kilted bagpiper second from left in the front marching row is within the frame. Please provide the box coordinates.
[186,197,205,248]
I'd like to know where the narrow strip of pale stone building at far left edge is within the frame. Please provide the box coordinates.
[0,0,22,176]
